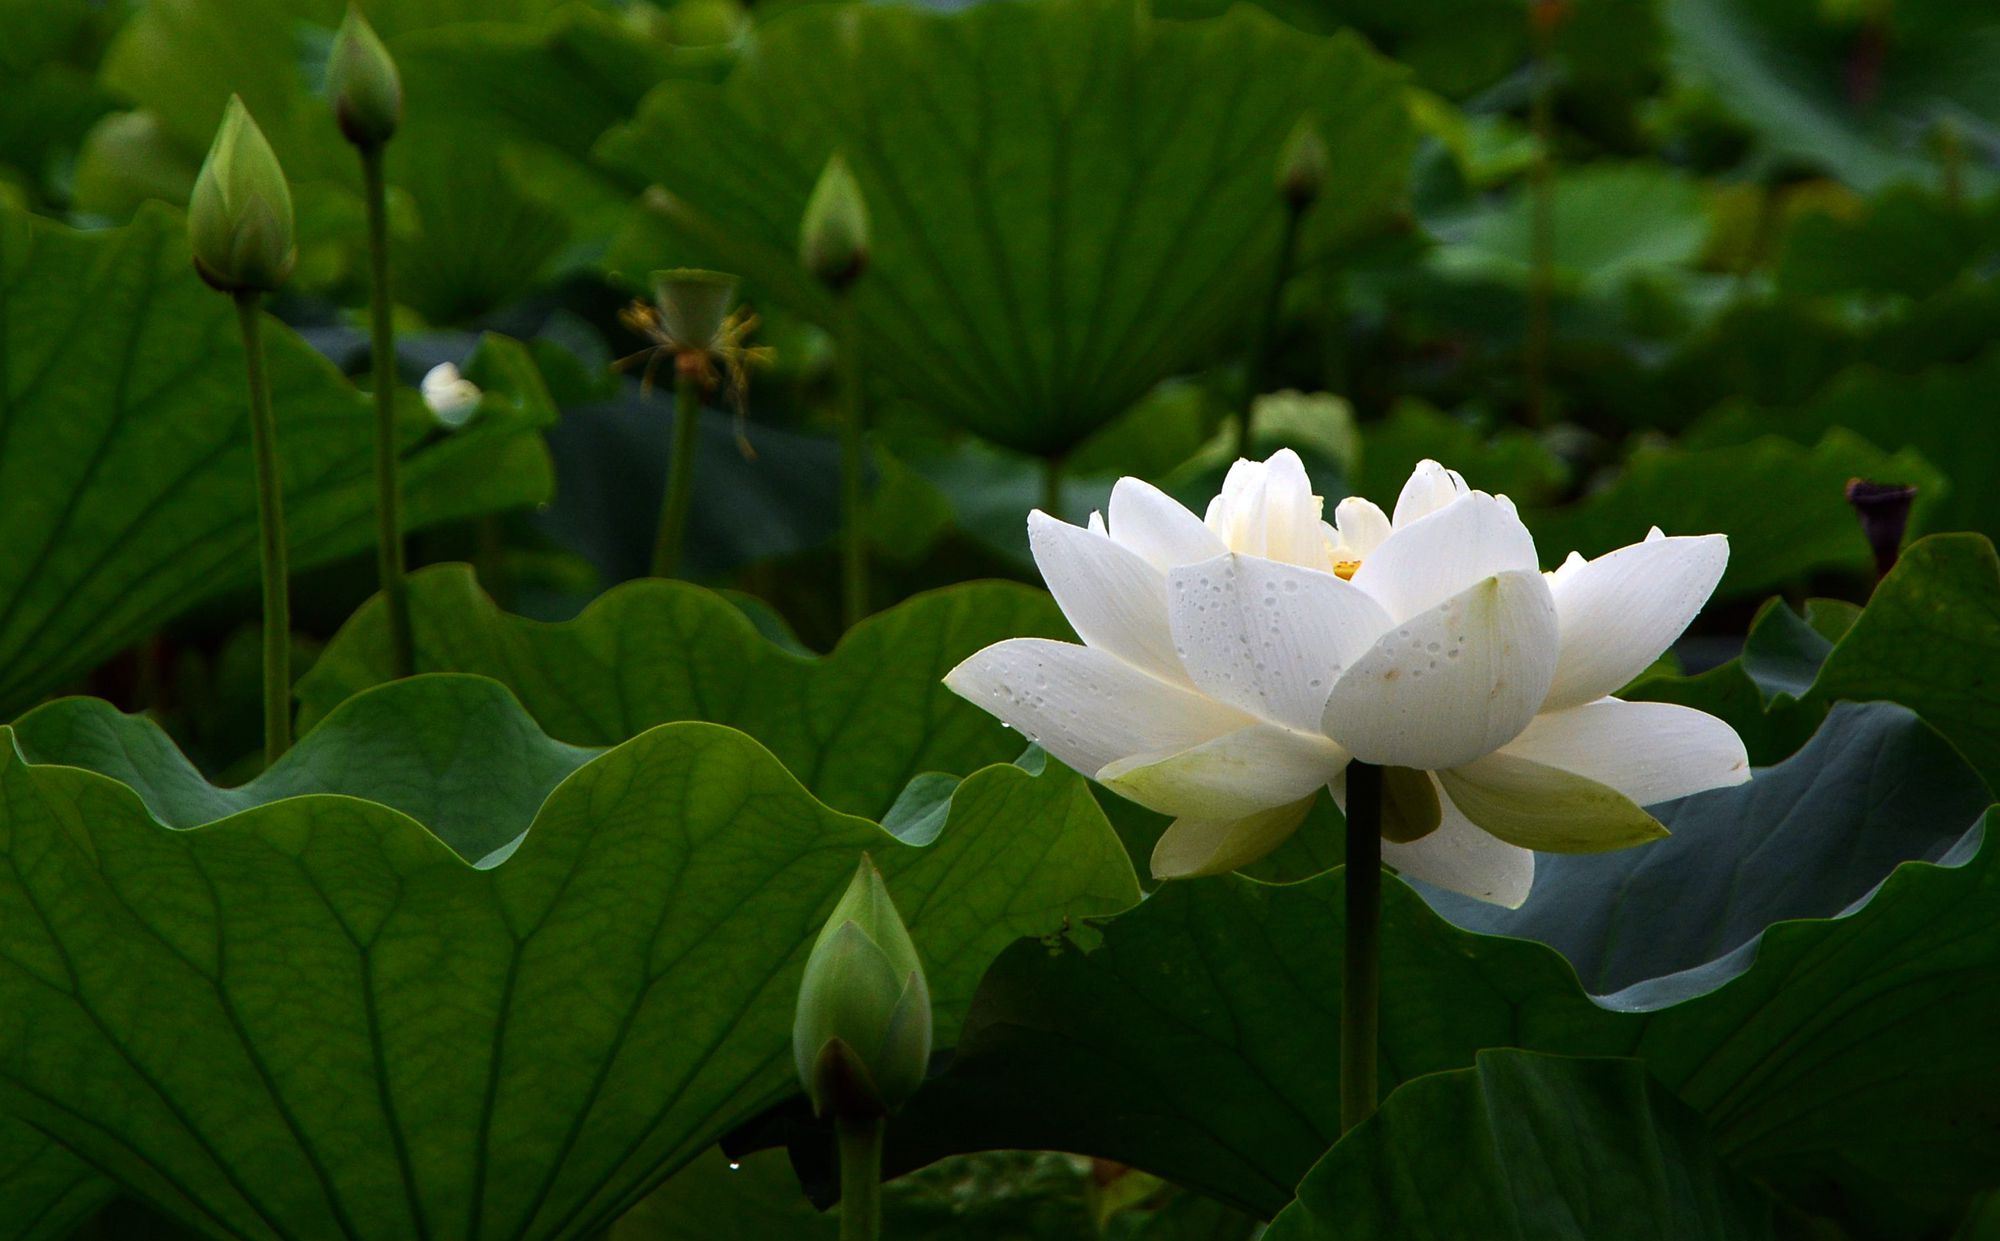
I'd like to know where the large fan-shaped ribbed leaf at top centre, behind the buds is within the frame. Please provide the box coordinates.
[602,0,1414,452]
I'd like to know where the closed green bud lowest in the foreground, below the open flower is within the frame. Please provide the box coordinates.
[792,855,930,1119]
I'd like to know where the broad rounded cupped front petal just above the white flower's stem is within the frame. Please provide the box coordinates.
[1322,572,1556,771]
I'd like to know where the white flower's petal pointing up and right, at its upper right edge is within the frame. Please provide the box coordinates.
[1536,530,1730,711]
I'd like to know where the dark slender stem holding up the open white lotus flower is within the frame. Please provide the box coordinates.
[1340,763,1382,1133]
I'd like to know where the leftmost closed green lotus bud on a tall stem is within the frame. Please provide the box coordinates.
[188,94,298,292]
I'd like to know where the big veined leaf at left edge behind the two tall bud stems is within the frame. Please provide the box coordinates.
[0,208,552,719]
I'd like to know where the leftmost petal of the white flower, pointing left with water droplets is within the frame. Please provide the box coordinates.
[944,639,1256,775]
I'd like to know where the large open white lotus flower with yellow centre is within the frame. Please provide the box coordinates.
[946,450,1750,907]
